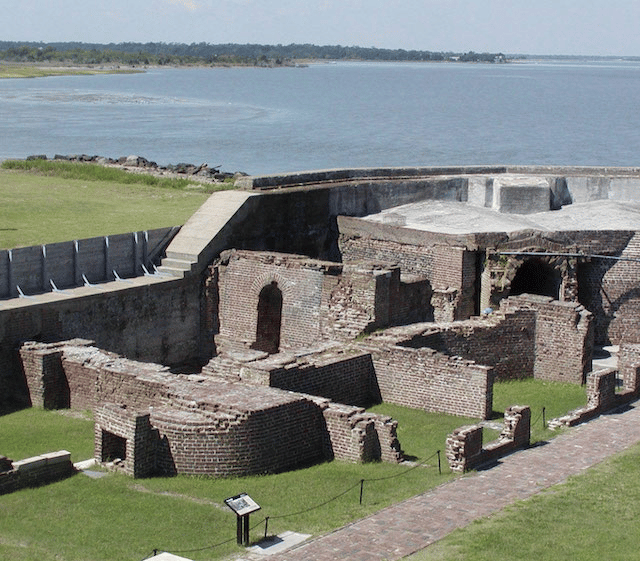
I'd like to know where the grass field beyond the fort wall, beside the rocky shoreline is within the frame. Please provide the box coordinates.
[0,162,220,249]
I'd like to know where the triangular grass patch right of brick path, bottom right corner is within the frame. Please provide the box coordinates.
[407,445,640,561]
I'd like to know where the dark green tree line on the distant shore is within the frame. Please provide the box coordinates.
[0,41,507,65]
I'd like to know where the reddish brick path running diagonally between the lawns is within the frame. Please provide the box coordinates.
[258,402,640,561]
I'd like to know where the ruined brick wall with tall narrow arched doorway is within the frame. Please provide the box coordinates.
[215,251,412,349]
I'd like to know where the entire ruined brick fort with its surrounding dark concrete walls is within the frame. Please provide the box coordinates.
[0,168,640,476]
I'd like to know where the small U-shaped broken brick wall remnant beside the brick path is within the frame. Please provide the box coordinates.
[446,405,531,473]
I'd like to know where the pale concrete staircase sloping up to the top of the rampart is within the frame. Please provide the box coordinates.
[158,191,259,277]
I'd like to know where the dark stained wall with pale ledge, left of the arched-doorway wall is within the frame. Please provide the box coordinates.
[0,278,202,403]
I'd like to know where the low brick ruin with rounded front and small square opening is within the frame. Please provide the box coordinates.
[21,343,402,477]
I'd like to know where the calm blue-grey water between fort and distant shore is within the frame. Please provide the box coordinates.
[0,62,640,174]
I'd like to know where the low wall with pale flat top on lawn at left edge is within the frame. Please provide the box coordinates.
[0,450,75,495]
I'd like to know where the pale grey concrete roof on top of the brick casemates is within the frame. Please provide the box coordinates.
[364,200,640,234]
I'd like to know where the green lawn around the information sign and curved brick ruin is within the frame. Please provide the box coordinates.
[0,382,592,561]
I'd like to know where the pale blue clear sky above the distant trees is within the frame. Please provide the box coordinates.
[0,0,640,56]
